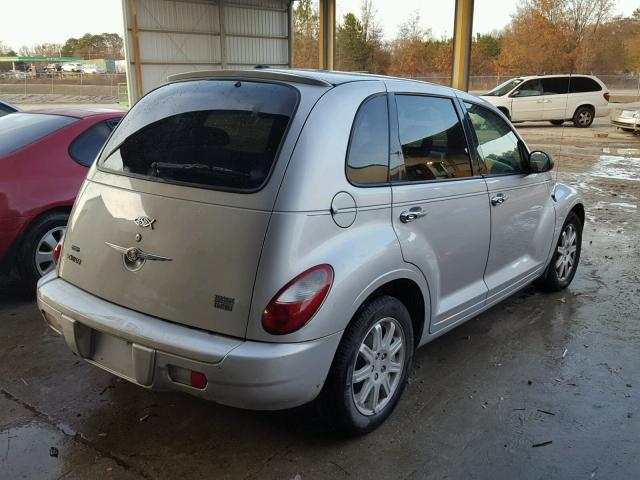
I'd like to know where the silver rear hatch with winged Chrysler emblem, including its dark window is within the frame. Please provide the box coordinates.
[59,77,328,337]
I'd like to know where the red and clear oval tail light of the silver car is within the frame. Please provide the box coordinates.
[262,264,333,335]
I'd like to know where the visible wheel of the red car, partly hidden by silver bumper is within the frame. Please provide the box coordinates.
[17,212,69,293]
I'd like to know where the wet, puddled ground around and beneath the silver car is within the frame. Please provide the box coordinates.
[0,115,640,480]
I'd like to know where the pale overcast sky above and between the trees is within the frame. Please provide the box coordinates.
[0,0,640,50]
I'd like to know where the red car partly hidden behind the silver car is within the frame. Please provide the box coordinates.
[0,109,125,289]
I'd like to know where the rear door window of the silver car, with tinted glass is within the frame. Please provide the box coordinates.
[391,95,473,182]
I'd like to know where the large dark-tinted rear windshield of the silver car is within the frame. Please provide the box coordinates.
[98,80,298,192]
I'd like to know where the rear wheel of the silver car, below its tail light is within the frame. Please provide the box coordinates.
[318,296,414,435]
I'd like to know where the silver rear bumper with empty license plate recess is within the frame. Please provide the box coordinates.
[37,273,341,410]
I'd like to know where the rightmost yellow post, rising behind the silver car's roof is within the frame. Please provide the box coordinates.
[451,0,473,90]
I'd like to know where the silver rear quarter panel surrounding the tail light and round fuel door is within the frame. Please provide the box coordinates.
[247,81,429,342]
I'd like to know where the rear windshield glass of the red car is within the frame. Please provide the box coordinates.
[0,113,76,156]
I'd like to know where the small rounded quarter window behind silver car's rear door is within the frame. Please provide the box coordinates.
[347,95,389,185]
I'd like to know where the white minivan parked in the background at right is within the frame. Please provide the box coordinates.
[481,75,610,128]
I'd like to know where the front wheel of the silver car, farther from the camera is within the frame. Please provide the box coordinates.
[535,212,582,292]
